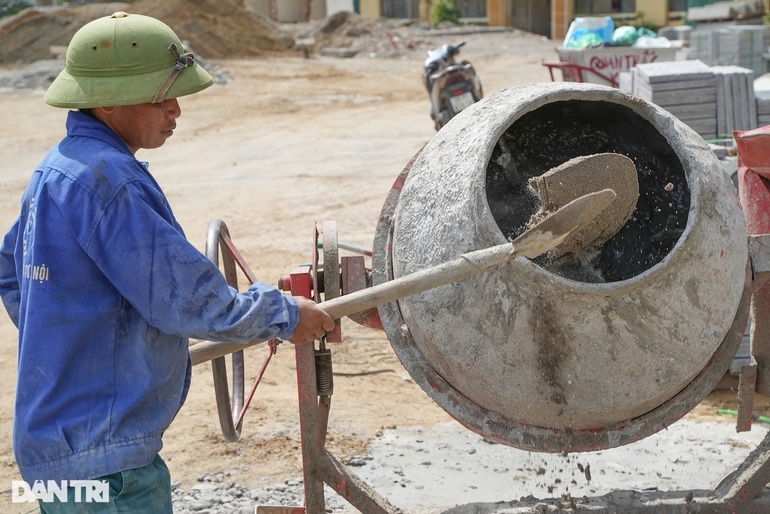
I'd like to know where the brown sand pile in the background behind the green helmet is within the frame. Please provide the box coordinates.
[0,0,294,64]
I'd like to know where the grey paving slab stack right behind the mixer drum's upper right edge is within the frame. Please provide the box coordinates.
[621,60,757,140]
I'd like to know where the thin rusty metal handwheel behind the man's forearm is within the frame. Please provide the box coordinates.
[206,220,245,442]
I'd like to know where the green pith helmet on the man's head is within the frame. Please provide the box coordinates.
[45,12,214,109]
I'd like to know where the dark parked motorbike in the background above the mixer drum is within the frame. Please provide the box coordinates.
[422,41,484,130]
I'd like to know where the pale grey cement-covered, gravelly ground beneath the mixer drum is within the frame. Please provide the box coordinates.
[173,418,768,514]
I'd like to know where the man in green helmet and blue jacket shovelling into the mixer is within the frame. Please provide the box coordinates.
[0,13,334,514]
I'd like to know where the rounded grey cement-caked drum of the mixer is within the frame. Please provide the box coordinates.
[373,83,751,452]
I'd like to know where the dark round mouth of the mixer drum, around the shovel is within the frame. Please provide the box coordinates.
[486,100,690,282]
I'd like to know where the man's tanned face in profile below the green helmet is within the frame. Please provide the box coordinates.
[93,98,182,154]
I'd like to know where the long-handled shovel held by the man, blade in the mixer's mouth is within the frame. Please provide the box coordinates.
[190,189,616,364]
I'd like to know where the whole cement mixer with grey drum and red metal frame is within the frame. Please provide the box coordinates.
[191,83,770,514]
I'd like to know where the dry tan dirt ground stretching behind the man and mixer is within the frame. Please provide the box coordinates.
[0,13,770,512]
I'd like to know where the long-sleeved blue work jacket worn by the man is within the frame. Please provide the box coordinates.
[0,111,299,484]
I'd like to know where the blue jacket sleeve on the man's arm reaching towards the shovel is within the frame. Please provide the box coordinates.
[84,175,299,343]
